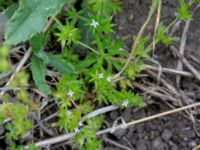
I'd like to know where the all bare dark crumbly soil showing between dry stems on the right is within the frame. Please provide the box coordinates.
[105,0,200,150]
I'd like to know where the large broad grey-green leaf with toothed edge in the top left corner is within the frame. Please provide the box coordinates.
[5,0,68,44]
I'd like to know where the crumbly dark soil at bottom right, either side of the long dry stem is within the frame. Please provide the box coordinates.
[106,104,200,150]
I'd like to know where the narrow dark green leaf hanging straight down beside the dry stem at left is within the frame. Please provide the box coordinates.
[31,56,51,95]
